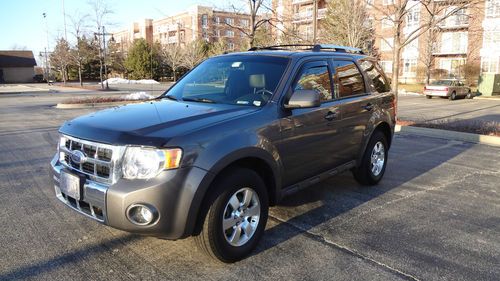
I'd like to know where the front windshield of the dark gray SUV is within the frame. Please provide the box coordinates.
[164,55,288,106]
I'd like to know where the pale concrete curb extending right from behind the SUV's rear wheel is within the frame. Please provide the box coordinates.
[394,125,500,146]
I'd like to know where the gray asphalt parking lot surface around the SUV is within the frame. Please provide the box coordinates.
[0,91,500,280]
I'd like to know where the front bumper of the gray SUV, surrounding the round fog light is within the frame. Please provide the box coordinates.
[51,154,207,239]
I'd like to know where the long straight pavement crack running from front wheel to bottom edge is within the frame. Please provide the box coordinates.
[269,216,420,281]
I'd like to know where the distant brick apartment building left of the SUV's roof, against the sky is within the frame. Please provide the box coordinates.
[113,6,254,51]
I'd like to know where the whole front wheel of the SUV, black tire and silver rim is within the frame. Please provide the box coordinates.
[195,168,269,263]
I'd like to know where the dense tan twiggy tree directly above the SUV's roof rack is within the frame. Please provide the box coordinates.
[322,0,374,49]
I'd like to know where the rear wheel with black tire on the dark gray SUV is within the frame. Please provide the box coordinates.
[352,131,388,185]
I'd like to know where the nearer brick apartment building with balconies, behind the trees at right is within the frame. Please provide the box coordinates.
[273,0,500,84]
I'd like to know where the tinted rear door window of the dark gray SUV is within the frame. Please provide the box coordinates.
[333,61,365,98]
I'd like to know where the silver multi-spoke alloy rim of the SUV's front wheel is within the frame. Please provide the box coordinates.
[222,187,260,247]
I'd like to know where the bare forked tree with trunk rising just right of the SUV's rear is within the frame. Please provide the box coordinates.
[367,0,481,93]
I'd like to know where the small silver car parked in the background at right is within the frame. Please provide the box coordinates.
[424,80,474,100]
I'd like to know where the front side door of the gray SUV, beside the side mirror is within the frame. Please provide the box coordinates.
[278,60,345,186]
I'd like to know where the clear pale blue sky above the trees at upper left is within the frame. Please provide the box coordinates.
[0,0,229,59]
